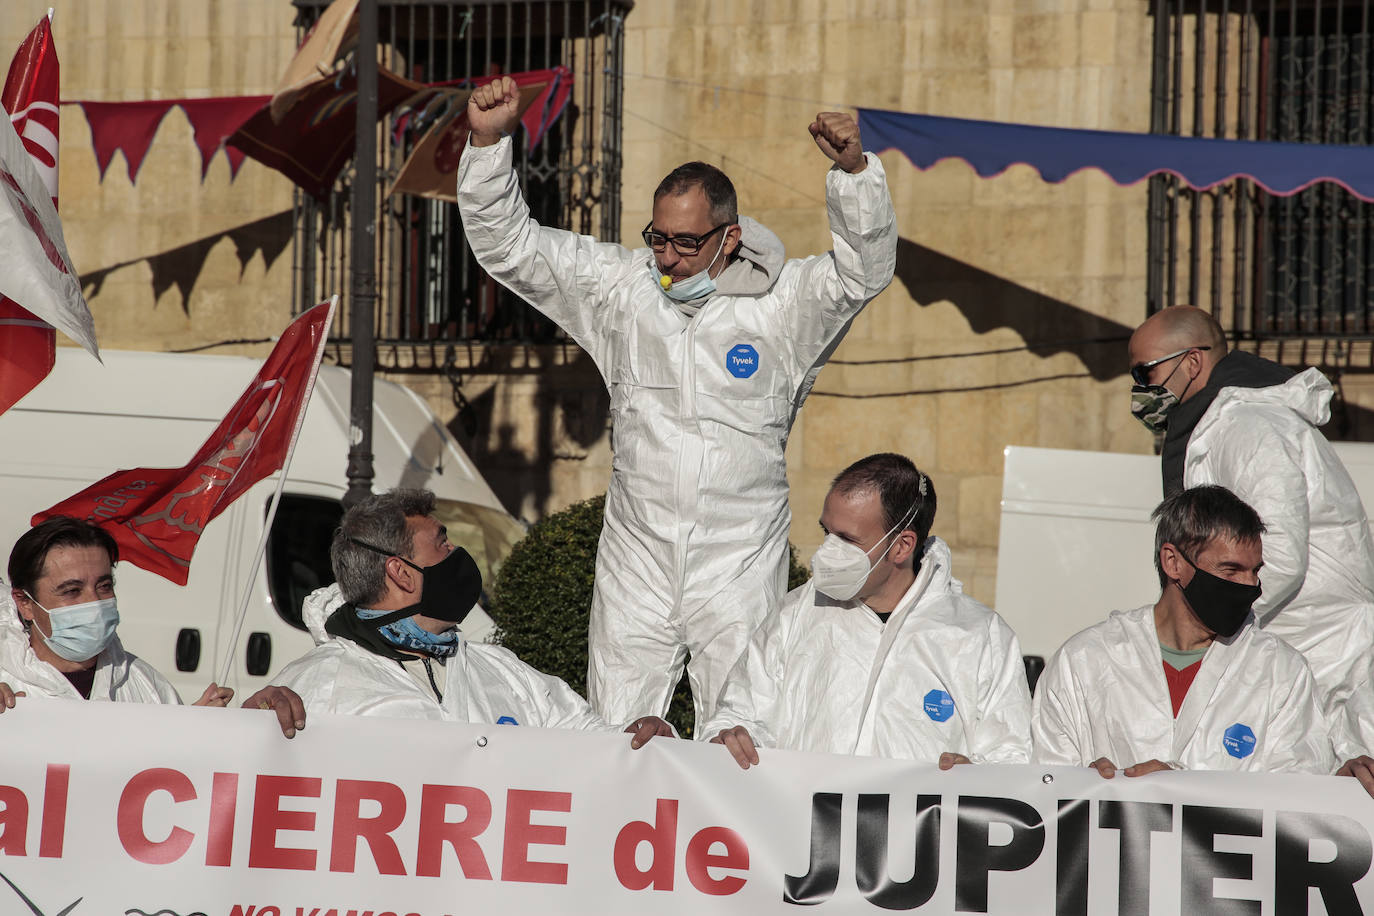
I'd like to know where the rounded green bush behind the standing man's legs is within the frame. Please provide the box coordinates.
[486,496,808,737]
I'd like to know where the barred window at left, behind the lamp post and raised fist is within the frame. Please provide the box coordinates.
[293,0,632,345]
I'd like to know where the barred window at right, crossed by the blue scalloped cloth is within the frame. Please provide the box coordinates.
[1147,0,1374,338]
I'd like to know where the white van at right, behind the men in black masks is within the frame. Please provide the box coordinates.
[996,442,1374,681]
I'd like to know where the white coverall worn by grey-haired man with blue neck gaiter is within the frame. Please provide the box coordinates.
[273,585,620,732]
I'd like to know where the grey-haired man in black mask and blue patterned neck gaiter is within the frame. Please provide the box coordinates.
[269,489,673,747]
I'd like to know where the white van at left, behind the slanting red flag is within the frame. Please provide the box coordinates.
[0,347,523,702]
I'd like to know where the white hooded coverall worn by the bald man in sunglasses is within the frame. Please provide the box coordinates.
[1183,369,1374,757]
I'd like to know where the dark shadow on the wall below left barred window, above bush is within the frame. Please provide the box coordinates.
[448,343,610,518]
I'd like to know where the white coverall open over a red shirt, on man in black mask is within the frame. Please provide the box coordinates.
[1032,604,1336,773]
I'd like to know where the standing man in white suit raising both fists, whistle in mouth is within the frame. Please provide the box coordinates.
[458,78,897,721]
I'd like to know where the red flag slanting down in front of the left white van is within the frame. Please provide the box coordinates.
[32,301,334,585]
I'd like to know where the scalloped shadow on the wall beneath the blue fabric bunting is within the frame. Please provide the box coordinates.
[897,239,1135,382]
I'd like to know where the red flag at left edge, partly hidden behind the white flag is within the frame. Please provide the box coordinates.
[0,16,59,413]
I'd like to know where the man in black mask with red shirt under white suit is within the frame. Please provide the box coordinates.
[1033,486,1336,779]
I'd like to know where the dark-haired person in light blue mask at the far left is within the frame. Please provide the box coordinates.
[0,515,305,737]
